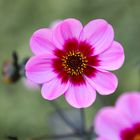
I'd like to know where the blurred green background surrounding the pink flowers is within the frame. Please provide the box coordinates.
[0,0,140,140]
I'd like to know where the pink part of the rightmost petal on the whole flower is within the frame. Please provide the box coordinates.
[98,41,124,70]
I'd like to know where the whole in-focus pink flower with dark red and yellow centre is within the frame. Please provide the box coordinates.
[26,19,124,108]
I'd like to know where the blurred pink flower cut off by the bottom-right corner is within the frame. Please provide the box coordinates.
[94,92,140,140]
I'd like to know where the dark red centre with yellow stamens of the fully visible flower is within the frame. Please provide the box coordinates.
[53,39,99,85]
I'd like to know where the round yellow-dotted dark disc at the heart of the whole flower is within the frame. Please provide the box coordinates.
[62,51,88,75]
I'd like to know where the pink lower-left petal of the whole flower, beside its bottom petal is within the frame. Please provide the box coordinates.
[41,78,69,100]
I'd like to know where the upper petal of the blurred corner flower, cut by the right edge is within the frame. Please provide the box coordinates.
[116,92,140,123]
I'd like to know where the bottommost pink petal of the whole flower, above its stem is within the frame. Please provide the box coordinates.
[65,83,96,108]
